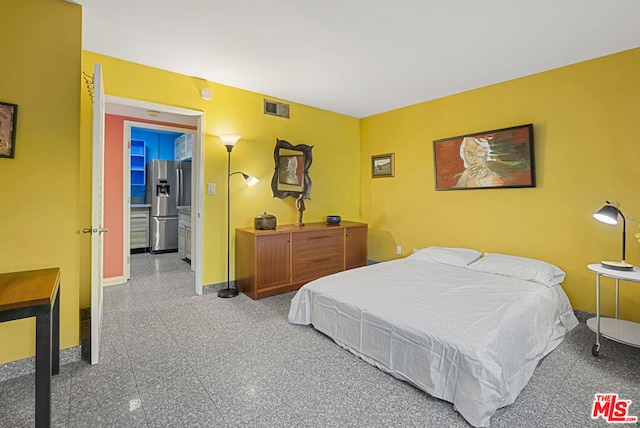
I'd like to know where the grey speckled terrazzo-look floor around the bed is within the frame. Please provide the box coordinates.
[0,254,640,428]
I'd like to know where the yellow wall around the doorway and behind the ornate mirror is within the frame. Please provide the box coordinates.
[81,52,360,300]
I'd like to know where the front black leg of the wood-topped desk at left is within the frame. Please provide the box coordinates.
[36,311,53,428]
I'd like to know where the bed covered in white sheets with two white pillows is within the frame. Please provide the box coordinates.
[289,247,578,427]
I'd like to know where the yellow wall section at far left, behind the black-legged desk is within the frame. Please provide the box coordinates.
[0,0,82,364]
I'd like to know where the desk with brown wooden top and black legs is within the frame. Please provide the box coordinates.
[0,268,60,428]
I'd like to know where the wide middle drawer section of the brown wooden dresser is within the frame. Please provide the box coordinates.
[292,229,344,281]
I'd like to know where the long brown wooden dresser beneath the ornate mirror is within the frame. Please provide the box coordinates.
[236,221,367,299]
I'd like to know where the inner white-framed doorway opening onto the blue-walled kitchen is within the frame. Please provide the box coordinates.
[123,120,195,280]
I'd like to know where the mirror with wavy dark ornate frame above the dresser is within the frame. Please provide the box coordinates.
[271,139,313,199]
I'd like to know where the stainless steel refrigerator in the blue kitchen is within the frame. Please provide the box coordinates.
[147,159,191,252]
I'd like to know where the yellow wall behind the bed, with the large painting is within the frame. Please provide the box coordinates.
[360,49,640,321]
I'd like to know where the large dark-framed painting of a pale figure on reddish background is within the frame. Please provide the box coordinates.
[433,124,536,190]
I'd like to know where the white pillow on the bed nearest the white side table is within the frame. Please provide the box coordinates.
[467,253,565,287]
